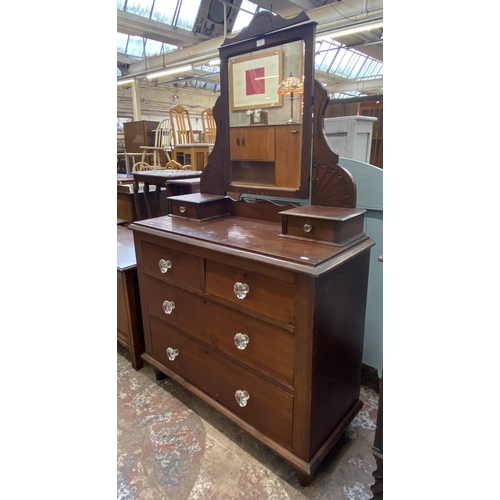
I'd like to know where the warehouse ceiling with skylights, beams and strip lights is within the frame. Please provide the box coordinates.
[117,0,383,98]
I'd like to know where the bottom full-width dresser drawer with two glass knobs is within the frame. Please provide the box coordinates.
[150,318,293,449]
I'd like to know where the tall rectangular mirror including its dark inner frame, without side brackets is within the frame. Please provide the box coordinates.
[220,13,316,199]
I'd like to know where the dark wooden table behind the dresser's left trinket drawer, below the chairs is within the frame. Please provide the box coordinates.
[132,169,201,220]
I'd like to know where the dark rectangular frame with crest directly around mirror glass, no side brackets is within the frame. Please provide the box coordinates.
[217,12,317,199]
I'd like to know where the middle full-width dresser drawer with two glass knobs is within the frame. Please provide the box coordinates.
[146,276,294,387]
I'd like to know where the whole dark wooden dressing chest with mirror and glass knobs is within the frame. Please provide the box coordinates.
[129,11,374,486]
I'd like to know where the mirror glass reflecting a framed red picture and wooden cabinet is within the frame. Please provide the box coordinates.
[228,40,304,190]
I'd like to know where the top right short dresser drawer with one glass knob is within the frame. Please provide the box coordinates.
[206,261,295,325]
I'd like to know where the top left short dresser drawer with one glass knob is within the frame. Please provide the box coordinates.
[142,241,203,290]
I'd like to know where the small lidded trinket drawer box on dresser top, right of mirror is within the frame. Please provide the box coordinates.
[280,205,366,246]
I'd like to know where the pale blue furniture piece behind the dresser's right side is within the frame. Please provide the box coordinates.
[339,157,384,377]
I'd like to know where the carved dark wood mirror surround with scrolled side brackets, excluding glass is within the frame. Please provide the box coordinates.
[200,12,356,208]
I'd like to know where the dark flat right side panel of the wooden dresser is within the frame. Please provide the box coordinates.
[310,250,370,458]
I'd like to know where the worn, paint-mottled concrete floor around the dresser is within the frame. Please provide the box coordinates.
[117,345,378,500]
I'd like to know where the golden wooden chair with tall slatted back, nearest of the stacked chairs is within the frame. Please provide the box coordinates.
[169,104,211,170]
